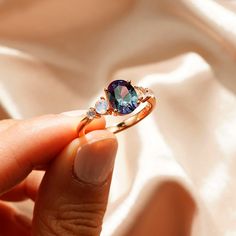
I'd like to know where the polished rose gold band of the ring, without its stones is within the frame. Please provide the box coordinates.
[77,87,156,137]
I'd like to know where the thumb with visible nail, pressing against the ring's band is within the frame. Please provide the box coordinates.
[33,130,117,236]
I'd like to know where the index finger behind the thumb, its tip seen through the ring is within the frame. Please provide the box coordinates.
[0,114,105,194]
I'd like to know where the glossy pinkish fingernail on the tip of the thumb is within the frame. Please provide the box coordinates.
[74,130,117,184]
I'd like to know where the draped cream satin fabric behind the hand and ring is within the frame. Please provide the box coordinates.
[0,0,236,236]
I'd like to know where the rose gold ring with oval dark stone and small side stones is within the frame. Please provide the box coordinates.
[77,80,156,137]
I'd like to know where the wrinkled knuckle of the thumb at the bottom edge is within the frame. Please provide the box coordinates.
[38,203,106,236]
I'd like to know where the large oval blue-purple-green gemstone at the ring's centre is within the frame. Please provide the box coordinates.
[107,80,138,114]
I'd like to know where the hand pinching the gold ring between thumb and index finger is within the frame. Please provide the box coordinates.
[0,114,117,236]
